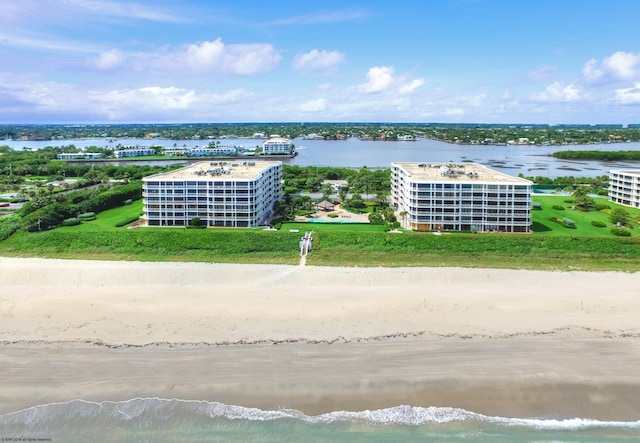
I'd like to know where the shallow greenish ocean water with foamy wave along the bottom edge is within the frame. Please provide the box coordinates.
[0,398,640,443]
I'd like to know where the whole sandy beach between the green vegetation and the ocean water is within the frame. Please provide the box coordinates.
[0,258,640,420]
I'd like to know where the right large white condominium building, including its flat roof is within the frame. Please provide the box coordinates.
[391,162,531,232]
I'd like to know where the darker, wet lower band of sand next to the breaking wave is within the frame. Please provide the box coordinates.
[0,336,640,421]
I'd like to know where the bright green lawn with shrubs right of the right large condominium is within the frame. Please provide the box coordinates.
[531,195,640,237]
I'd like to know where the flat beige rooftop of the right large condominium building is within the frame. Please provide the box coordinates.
[391,162,531,185]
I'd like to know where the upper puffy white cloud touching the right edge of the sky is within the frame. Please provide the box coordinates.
[582,51,640,83]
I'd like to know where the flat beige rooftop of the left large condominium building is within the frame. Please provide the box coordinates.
[143,161,282,181]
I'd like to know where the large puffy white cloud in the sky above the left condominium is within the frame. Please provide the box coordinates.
[179,38,282,75]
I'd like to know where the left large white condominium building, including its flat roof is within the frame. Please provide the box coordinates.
[142,161,282,227]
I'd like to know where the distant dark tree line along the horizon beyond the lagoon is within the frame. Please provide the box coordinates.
[5,122,640,145]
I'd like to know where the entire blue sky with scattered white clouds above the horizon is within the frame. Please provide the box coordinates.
[0,0,640,124]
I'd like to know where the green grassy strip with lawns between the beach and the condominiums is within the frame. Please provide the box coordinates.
[0,196,640,272]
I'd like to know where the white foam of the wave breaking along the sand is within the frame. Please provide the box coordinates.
[0,398,640,430]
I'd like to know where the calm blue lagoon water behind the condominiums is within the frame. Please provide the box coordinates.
[5,138,640,178]
